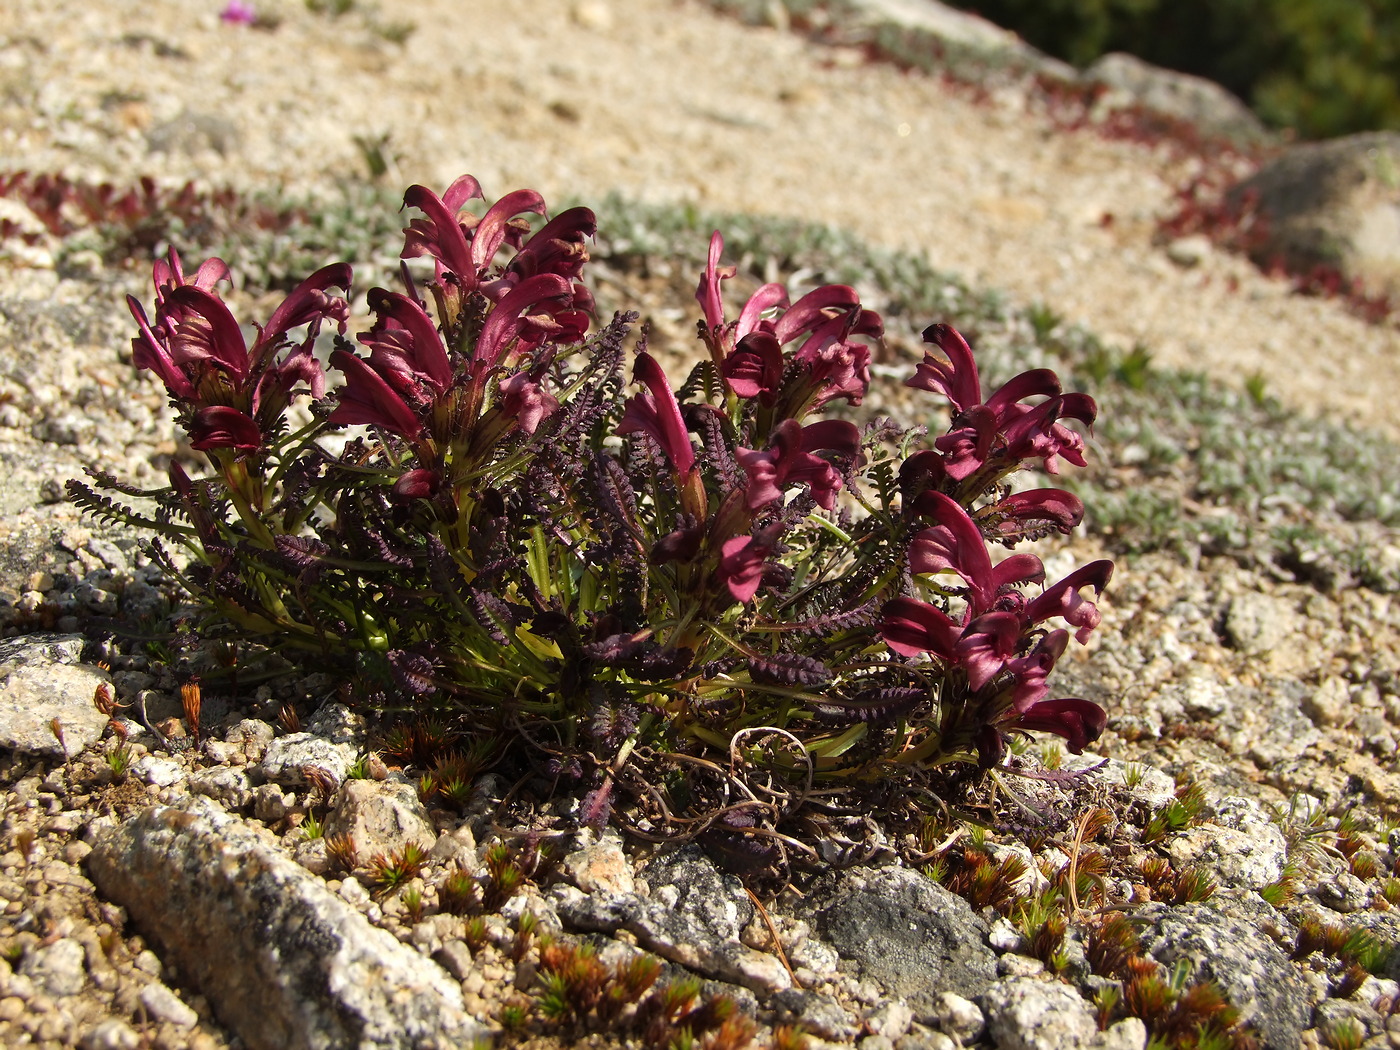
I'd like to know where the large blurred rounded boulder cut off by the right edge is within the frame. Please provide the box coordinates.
[1228,132,1400,297]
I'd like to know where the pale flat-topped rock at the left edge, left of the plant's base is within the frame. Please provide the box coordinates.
[0,634,111,759]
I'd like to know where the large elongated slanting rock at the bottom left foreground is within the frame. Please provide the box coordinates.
[88,799,489,1050]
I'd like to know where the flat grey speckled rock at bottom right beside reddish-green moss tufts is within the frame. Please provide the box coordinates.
[1137,893,1309,1050]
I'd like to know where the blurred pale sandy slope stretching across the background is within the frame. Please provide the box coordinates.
[0,0,1400,434]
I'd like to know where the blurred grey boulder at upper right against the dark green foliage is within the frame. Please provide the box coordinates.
[1082,52,1264,141]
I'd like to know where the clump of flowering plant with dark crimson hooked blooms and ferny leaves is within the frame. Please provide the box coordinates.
[70,176,1112,868]
